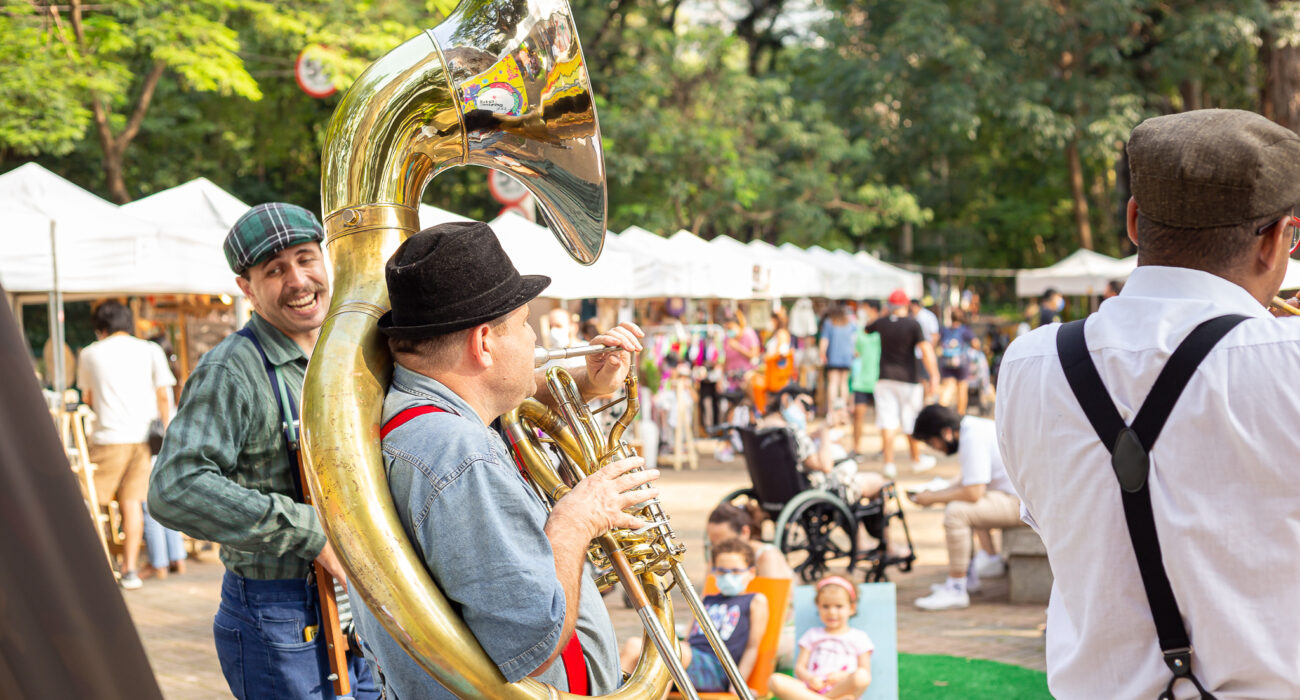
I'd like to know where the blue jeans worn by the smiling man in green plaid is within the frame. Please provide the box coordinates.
[212,571,380,700]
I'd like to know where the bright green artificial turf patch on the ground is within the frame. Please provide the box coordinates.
[898,654,1052,700]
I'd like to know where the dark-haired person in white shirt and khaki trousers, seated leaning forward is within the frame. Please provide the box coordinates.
[907,405,1022,610]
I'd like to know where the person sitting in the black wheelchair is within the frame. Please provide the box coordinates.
[758,386,885,504]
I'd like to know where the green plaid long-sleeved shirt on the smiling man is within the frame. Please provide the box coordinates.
[150,314,325,579]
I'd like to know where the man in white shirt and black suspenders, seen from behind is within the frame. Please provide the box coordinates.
[997,109,1300,699]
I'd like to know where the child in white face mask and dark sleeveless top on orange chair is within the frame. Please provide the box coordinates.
[619,537,767,692]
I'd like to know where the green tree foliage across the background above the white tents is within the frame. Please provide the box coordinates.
[0,0,1300,267]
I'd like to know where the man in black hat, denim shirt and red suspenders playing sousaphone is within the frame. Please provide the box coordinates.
[355,221,659,700]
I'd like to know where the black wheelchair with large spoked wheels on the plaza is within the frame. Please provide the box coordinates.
[722,425,917,583]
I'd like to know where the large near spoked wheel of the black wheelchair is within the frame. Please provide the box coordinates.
[776,491,857,583]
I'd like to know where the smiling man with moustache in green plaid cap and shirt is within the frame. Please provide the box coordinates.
[150,203,378,700]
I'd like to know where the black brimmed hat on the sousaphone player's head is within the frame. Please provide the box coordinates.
[378,221,551,340]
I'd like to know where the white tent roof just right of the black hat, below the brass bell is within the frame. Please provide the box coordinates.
[490,212,633,299]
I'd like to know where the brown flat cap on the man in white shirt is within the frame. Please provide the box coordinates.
[1128,109,1300,229]
